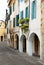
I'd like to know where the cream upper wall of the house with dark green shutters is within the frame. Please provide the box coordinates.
[10,0,19,28]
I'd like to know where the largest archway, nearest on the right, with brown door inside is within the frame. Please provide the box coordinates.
[29,33,40,57]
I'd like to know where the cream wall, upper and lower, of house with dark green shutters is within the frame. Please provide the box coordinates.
[10,0,19,48]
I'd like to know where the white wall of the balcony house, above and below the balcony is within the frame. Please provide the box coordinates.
[19,0,29,52]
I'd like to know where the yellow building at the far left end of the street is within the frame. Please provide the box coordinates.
[0,20,7,42]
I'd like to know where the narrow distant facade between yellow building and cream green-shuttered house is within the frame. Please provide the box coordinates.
[5,9,10,46]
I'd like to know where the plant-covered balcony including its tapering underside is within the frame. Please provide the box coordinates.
[18,18,29,32]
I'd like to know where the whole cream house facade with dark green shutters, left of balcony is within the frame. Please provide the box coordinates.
[8,0,19,49]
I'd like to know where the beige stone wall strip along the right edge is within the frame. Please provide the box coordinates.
[41,0,44,61]
